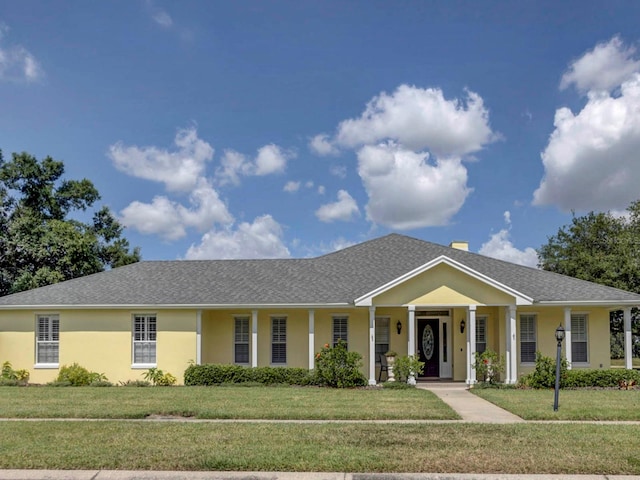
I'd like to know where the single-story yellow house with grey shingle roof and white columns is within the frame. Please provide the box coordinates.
[0,234,640,384]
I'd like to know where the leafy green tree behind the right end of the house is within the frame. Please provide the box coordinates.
[538,201,640,358]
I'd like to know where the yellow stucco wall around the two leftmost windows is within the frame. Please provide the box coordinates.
[0,310,196,383]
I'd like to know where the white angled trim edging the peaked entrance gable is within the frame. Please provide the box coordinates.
[354,255,533,307]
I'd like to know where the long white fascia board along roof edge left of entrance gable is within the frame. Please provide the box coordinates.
[0,303,354,310]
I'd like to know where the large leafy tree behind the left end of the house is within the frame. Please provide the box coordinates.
[0,150,140,295]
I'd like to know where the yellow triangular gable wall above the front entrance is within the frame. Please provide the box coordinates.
[373,264,514,306]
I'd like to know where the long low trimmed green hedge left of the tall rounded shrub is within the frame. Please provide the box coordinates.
[184,363,314,386]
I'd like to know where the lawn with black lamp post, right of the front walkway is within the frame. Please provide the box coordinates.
[471,389,640,420]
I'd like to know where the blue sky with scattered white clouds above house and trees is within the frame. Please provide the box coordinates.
[0,0,640,265]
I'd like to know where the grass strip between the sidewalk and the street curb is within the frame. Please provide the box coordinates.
[0,420,640,474]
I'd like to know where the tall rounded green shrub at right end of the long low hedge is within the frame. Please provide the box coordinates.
[315,340,367,388]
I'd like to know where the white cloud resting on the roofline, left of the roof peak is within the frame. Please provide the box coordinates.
[186,215,290,260]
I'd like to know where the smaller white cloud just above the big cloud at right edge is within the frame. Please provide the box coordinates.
[560,36,640,92]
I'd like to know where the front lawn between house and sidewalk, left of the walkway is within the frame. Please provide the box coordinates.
[0,386,460,420]
